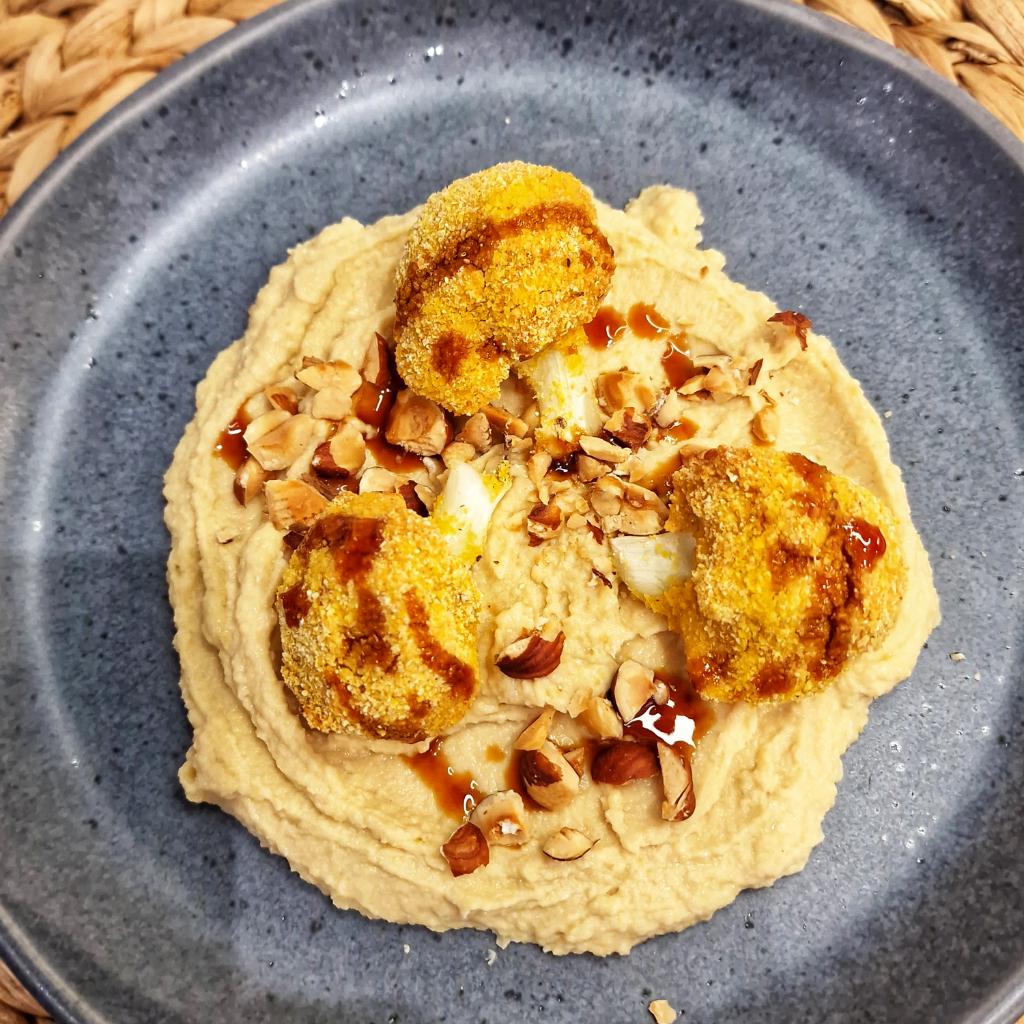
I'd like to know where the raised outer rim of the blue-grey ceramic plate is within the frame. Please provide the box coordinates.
[0,0,1024,1024]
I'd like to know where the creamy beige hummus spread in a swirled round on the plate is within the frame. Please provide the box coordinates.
[166,180,939,955]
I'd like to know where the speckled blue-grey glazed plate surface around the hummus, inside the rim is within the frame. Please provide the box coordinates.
[0,0,1024,1024]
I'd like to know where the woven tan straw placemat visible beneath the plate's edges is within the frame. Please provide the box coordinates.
[0,0,1024,1024]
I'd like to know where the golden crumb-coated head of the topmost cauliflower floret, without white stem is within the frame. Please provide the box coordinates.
[394,162,614,413]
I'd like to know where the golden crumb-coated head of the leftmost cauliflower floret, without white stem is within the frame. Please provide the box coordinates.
[278,493,480,742]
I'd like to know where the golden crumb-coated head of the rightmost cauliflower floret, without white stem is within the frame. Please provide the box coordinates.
[656,447,907,701]
